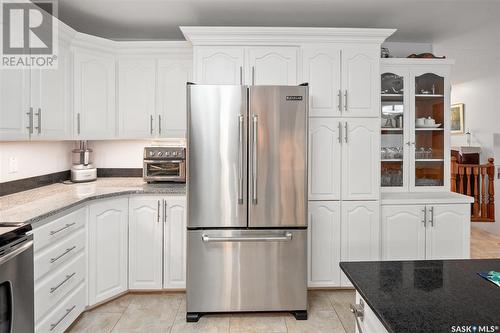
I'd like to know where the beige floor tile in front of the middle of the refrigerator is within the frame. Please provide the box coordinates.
[229,313,291,333]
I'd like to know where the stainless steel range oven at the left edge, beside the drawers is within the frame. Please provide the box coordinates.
[0,224,35,333]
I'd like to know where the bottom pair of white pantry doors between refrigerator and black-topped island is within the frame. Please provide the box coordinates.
[308,201,380,288]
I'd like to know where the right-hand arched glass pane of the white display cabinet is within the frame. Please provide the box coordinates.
[414,73,445,188]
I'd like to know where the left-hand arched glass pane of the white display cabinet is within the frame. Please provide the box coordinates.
[380,72,407,190]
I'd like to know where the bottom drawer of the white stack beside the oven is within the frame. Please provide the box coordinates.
[35,283,85,333]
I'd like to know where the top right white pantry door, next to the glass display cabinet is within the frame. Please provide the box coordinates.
[342,46,380,117]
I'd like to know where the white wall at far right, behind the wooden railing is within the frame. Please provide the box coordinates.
[433,22,500,235]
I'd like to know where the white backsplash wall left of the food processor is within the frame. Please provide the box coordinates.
[0,141,73,183]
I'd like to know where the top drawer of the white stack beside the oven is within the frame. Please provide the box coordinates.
[33,207,87,253]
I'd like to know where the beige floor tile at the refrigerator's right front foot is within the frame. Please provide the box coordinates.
[286,310,345,333]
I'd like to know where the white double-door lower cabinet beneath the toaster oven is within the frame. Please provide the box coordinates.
[129,196,186,289]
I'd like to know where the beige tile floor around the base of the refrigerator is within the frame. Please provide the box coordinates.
[69,290,354,333]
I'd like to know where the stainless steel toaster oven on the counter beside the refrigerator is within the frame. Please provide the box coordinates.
[143,147,186,183]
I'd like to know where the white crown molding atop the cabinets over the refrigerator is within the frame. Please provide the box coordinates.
[180,26,396,46]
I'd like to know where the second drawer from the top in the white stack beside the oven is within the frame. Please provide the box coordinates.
[35,228,85,281]
